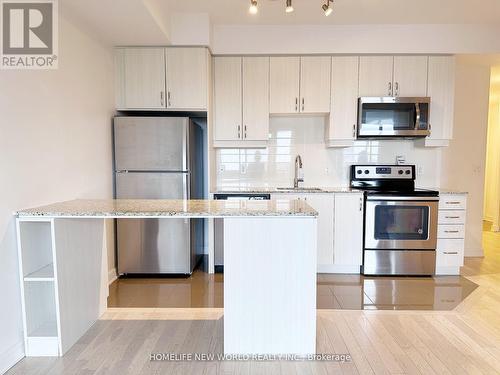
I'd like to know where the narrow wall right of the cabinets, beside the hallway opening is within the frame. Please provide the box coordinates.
[441,56,490,256]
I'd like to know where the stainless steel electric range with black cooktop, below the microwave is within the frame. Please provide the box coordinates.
[351,165,439,276]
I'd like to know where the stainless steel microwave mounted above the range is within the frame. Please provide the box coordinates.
[358,97,431,138]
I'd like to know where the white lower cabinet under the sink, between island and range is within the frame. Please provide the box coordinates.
[272,193,363,273]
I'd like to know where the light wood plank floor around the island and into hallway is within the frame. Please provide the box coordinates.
[9,228,500,375]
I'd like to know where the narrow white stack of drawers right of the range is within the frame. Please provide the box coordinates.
[436,194,467,275]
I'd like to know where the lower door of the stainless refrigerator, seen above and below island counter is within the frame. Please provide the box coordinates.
[116,172,191,274]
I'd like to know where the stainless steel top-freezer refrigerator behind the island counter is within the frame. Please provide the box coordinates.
[114,116,204,275]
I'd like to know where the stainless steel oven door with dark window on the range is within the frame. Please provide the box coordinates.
[365,196,439,250]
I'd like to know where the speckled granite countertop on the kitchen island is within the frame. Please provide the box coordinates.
[15,199,318,218]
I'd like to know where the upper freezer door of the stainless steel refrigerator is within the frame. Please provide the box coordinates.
[114,117,189,171]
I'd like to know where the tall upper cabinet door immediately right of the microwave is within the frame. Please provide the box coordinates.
[425,56,455,146]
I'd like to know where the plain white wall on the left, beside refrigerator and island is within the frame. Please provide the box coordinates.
[0,17,114,373]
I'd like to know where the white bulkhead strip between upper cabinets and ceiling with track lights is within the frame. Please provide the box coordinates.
[212,23,500,55]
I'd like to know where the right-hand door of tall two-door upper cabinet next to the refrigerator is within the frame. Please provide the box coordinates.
[243,57,269,141]
